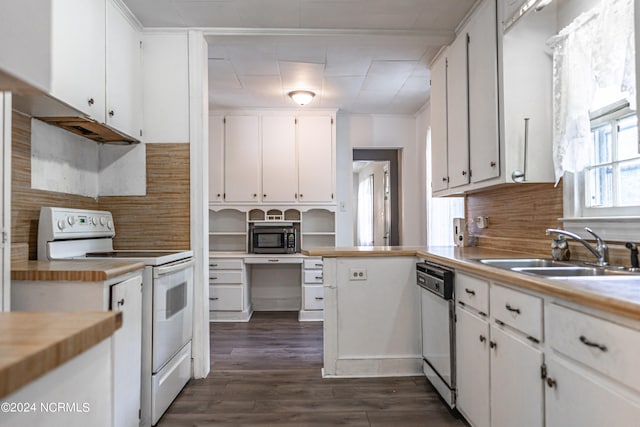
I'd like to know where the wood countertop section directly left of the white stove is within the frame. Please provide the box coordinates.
[11,259,144,282]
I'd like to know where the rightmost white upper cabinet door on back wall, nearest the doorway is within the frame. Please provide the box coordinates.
[297,116,335,203]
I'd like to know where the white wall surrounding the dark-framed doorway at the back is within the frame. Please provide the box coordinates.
[336,113,426,246]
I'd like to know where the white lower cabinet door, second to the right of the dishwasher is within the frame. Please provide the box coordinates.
[491,326,544,427]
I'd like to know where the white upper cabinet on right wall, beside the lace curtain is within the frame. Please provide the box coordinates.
[431,0,556,196]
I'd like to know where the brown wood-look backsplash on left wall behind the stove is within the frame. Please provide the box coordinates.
[11,112,190,259]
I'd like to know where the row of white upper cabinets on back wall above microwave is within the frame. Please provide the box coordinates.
[209,112,335,205]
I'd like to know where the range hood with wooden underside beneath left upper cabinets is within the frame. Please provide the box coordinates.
[12,93,140,145]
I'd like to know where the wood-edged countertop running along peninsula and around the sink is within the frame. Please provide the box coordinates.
[302,246,640,320]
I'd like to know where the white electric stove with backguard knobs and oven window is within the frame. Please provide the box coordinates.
[38,207,194,426]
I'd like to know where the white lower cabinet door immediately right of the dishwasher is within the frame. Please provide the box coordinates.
[456,307,490,427]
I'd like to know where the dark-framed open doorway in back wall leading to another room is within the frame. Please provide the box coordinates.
[352,148,400,246]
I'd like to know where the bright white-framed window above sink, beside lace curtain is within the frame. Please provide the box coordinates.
[583,102,640,216]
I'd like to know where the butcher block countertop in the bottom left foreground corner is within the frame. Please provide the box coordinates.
[0,311,122,398]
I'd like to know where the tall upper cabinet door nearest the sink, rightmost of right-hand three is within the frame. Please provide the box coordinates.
[468,0,500,182]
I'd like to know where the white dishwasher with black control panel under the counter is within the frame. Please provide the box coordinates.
[416,262,456,408]
